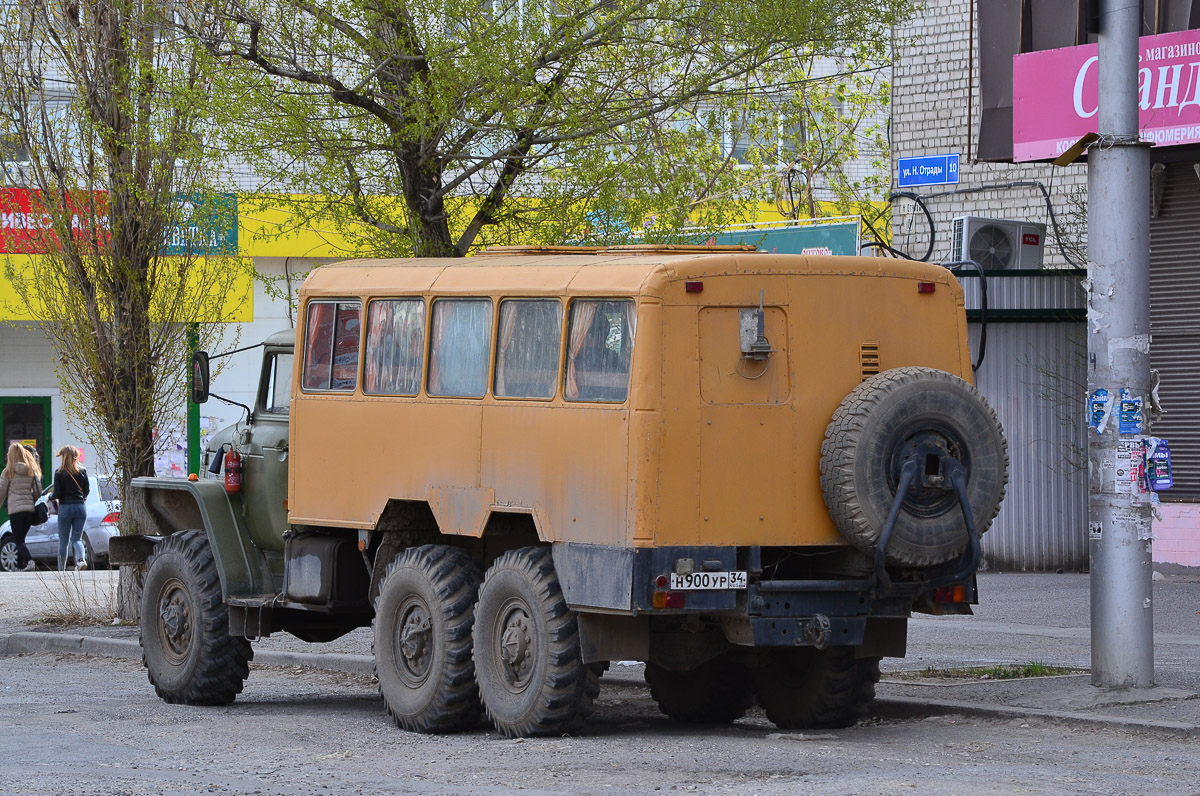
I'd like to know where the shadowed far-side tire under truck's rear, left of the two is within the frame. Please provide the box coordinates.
[646,658,754,724]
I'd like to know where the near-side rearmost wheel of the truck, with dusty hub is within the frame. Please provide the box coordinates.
[475,547,600,737]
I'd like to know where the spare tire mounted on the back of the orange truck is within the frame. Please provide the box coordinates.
[821,367,1008,567]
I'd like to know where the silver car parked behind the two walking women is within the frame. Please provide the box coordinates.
[0,473,121,573]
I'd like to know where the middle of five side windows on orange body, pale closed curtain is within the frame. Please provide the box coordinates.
[428,299,492,397]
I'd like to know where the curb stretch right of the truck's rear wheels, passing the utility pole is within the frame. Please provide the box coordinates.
[871,696,1200,738]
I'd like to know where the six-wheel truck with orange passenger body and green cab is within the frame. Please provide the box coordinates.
[113,246,1008,736]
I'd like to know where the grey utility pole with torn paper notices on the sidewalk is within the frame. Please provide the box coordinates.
[1087,0,1154,688]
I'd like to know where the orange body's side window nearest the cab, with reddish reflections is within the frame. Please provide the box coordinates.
[301,301,361,391]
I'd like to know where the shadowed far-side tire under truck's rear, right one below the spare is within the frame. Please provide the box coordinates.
[755,647,880,730]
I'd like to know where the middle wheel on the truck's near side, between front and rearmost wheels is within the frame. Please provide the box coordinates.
[373,545,482,732]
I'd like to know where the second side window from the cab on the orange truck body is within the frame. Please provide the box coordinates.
[362,299,425,395]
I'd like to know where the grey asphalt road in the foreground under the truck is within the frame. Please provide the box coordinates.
[0,654,1200,796]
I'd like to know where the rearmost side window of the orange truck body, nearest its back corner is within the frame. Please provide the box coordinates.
[564,299,637,403]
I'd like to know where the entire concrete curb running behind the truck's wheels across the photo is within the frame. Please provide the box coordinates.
[0,632,1200,738]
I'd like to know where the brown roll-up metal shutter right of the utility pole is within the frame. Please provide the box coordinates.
[1150,163,1200,501]
